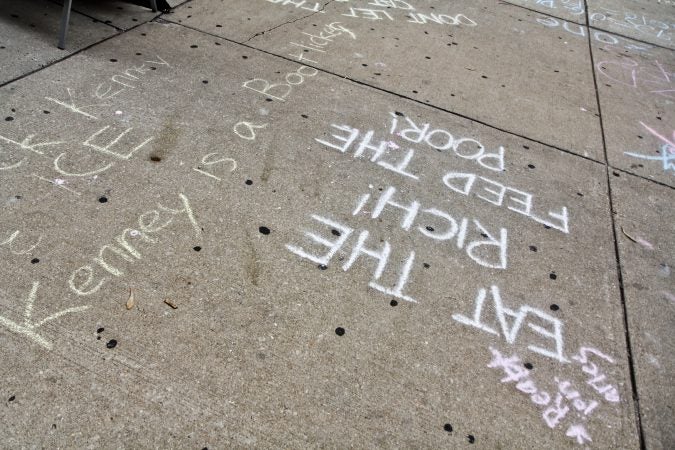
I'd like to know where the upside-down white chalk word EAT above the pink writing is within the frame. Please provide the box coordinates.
[452,286,570,363]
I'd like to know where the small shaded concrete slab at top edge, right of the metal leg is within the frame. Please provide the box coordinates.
[48,0,161,30]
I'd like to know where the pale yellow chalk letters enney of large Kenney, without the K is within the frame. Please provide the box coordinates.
[68,194,202,296]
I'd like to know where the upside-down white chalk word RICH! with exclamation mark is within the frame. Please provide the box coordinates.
[352,186,508,270]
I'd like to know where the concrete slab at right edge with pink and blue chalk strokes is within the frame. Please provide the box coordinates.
[593,35,675,186]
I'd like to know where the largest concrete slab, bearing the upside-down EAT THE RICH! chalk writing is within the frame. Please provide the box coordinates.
[0,21,638,448]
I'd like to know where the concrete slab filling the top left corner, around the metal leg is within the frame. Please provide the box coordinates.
[0,0,116,84]
